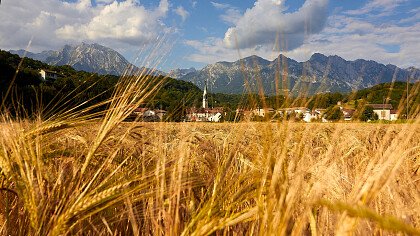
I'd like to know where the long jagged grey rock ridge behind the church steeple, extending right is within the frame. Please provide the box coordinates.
[180,53,420,95]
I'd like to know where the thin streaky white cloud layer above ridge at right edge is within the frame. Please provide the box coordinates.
[288,16,420,68]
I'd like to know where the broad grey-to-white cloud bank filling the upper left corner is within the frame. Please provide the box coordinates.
[0,0,170,51]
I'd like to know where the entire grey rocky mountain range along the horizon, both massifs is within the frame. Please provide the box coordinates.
[10,43,420,95]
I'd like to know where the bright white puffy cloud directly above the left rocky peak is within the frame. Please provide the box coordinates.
[55,0,169,44]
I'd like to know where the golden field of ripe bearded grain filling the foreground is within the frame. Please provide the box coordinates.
[0,121,420,235]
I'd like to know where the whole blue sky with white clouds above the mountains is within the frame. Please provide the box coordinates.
[0,0,420,71]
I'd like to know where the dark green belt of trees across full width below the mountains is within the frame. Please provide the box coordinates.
[0,50,420,121]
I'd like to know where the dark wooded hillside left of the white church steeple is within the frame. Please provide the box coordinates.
[0,50,201,120]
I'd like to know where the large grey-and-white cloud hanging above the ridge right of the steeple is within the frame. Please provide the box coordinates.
[185,0,328,63]
